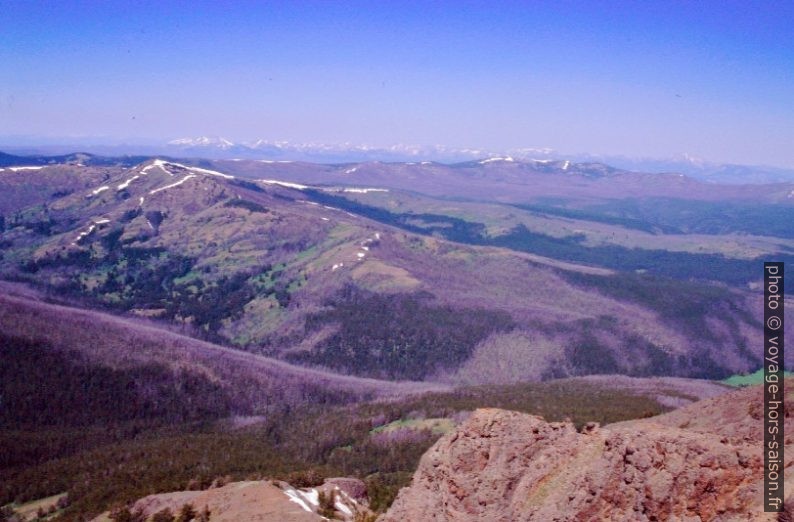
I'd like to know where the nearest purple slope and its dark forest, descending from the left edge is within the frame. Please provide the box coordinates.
[0,284,726,521]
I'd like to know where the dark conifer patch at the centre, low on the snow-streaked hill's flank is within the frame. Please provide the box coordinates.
[289,286,514,380]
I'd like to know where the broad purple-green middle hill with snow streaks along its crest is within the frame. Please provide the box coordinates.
[0,161,780,383]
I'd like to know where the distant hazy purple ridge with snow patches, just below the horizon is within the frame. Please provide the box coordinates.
[207,157,794,206]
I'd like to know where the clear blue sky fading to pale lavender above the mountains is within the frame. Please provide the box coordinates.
[0,0,794,166]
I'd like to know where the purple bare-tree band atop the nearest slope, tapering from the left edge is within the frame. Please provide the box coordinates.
[0,284,441,414]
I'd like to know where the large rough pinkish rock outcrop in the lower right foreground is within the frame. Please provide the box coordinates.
[382,382,794,522]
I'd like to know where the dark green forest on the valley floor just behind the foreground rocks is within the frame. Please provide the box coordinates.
[0,368,664,521]
